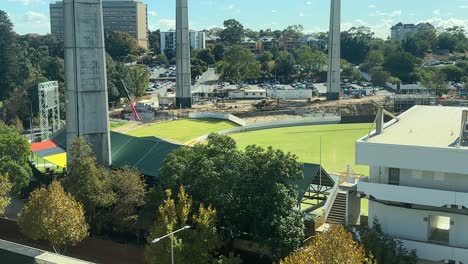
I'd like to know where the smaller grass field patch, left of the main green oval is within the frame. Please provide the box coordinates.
[126,119,236,143]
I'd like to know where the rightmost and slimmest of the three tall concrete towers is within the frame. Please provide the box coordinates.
[327,0,341,101]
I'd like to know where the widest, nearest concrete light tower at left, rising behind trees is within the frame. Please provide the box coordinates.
[63,0,111,166]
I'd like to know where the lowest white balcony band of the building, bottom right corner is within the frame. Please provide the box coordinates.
[398,239,468,263]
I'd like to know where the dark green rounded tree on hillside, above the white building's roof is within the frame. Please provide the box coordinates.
[383,52,419,83]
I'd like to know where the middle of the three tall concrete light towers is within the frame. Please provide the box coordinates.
[176,0,192,108]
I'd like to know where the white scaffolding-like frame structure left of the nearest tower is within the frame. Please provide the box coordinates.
[38,81,60,141]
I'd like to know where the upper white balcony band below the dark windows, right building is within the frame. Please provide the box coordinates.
[357,178,468,209]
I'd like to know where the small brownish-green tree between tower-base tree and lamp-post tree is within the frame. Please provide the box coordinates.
[111,168,146,228]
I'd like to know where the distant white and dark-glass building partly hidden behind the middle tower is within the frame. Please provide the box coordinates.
[160,30,206,58]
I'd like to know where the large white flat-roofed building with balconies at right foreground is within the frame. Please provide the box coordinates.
[356,106,468,263]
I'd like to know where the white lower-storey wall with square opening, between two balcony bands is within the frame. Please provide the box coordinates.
[369,201,468,249]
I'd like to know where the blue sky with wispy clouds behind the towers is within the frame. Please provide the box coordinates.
[0,0,468,38]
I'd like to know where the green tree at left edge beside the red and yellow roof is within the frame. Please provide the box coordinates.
[0,121,32,195]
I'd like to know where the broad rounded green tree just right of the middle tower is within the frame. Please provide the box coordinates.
[216,45,260,82]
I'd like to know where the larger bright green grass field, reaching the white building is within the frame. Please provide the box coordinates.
[231,124,371,175]
